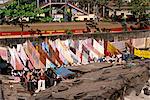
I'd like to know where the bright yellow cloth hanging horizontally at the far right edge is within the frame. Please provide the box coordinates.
[134,49,150,58]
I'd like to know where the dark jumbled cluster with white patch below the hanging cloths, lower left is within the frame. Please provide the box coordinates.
[11,68,57,94]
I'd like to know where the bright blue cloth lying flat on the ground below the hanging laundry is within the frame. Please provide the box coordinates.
[56,67,75,77]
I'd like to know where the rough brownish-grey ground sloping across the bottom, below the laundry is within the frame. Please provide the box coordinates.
[0,60,150,100]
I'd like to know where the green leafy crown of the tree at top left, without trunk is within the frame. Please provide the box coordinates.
[0,0,51,21]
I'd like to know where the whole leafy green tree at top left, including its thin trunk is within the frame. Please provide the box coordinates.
[0,0,51,31]
